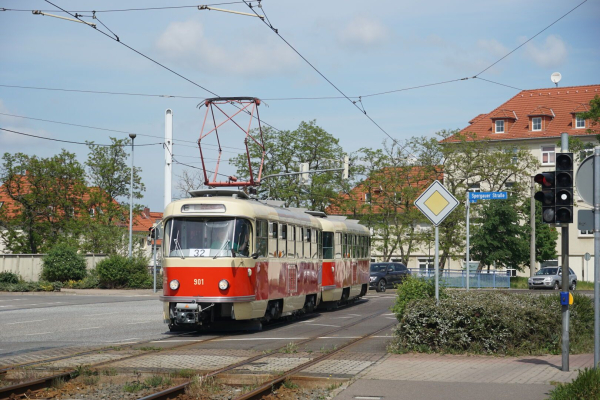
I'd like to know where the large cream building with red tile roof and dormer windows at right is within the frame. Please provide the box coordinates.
[443,85,600,280]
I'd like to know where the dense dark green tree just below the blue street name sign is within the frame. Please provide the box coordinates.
[471,196,530,270]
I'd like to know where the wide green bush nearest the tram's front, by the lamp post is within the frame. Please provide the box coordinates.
[96,254,152,289]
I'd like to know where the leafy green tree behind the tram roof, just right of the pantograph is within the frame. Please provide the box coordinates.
[230,121,344,211]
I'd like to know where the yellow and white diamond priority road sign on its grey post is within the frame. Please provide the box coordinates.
[415,181,458,302]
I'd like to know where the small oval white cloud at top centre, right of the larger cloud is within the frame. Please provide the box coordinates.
[337,16,390,49]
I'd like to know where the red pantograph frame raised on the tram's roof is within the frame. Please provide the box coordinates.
[198,97,265,187]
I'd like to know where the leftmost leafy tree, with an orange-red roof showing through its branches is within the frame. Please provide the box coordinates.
[0,149,87,254]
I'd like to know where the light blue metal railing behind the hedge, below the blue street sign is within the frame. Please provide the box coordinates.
[409,268,510,289]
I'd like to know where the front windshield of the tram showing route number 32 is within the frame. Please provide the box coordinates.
[165,217,252,258]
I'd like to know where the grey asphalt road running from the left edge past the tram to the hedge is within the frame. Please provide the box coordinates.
[0,291,395,364]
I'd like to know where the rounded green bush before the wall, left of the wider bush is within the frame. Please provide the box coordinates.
[42,244,87,282]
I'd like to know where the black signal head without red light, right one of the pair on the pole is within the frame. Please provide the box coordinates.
[555,153,573,224]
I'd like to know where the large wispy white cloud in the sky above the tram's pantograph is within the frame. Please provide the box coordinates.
[156,20,298,77]
